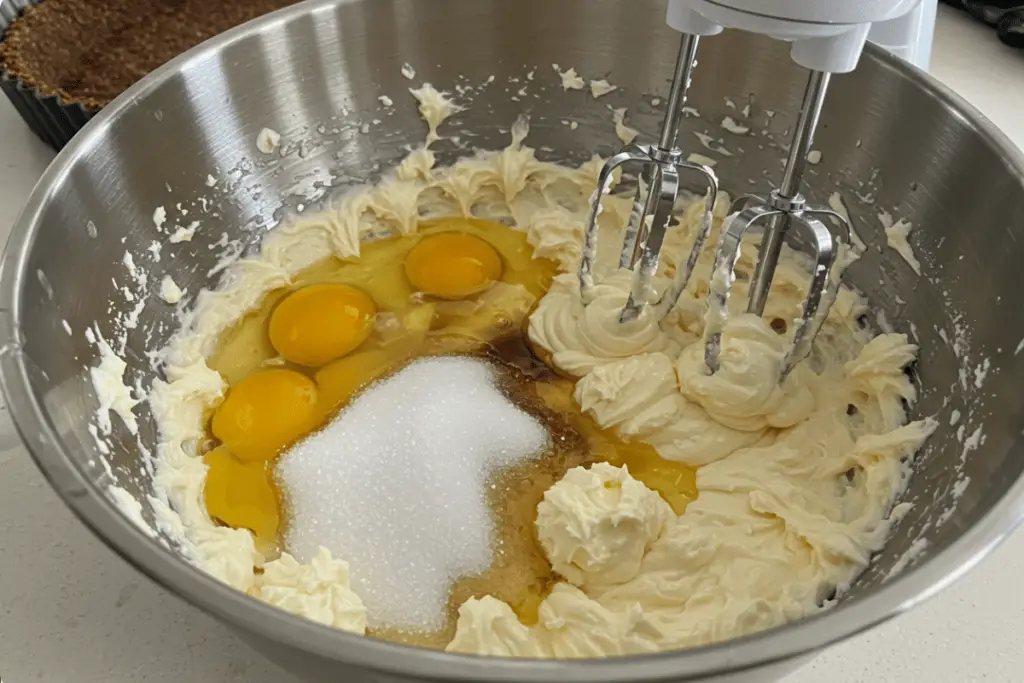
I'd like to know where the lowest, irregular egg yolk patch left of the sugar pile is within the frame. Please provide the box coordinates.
[203,445,281,543]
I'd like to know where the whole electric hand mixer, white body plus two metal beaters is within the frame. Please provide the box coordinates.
[580,0,935,374]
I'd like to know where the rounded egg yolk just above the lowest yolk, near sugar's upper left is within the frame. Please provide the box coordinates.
[210,369,318,462]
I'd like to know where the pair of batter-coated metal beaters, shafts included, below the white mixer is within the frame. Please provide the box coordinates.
[580,50,850,377]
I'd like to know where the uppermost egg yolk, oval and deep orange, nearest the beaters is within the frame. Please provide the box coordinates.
[406,232,502,299]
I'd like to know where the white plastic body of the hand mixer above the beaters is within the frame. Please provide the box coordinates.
[668,0,936,73]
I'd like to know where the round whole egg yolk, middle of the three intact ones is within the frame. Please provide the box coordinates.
[269,285,377,368]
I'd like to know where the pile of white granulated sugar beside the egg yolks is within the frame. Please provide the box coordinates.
[278,357,548,632]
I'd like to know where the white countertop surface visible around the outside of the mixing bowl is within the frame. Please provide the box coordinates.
[0,7,1024,683]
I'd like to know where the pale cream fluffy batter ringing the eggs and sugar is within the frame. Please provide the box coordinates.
[150,85,934,657]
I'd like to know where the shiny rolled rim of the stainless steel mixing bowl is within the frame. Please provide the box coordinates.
[0,0,1024,683]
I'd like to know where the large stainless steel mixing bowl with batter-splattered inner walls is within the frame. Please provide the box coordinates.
[0,0,1024,683]
